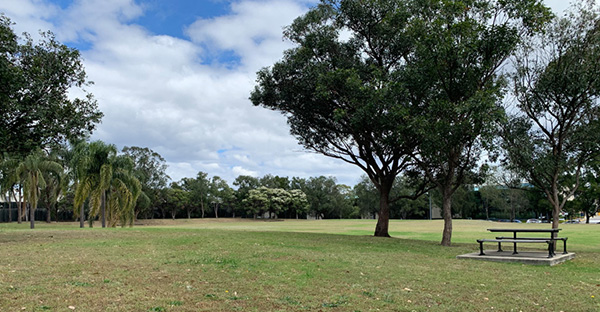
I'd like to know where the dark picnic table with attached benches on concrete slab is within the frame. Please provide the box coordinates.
[477,229,567,258]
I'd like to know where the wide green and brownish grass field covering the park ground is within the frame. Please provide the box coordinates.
[0,219,600,311]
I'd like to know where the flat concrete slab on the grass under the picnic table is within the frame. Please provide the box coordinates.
[456,250,575,265]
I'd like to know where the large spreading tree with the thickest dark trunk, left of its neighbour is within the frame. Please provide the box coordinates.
[250,0,432,236]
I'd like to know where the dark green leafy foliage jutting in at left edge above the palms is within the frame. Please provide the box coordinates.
[0,15,102,156]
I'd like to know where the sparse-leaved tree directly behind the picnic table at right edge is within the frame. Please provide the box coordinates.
[502,1,600,228]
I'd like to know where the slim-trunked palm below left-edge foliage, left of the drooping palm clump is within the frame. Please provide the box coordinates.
[16,150,63,229]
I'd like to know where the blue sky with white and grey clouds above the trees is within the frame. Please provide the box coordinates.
[0,0,568,185]
